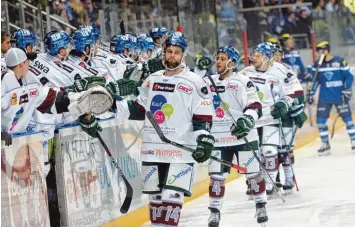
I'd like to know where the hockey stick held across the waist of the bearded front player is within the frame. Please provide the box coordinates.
[147,111,248,173]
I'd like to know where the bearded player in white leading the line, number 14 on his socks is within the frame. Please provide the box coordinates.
[116,32,214,226]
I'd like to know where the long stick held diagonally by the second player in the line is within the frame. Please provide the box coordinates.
[206,75,286,203]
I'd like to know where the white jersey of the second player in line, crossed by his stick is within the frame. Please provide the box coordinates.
[205,73,262,147]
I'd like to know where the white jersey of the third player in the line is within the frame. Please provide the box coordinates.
[239,63,294,128]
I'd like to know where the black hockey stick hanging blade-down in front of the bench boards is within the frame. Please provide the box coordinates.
[88,114,133,214]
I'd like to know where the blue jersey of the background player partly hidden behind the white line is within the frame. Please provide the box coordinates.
[283,49,307,82]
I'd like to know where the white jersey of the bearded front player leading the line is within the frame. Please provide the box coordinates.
[116,70,214,163]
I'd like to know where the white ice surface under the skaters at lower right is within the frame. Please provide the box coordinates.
[175,128,355,227]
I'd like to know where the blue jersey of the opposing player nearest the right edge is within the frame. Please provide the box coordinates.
[311,56,354,104]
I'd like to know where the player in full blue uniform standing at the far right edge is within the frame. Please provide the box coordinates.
[307,41,355,156]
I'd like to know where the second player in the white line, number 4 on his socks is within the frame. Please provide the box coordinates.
[205,46,268,227]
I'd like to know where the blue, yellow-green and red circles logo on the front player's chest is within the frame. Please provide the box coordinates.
[150,95,174,124]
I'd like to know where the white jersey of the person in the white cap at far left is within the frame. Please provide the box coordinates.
[1,69,57,133]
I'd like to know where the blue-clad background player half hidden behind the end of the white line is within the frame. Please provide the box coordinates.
[281,33,310,82]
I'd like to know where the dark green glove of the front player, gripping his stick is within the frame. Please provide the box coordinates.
[192,135,215,163]
